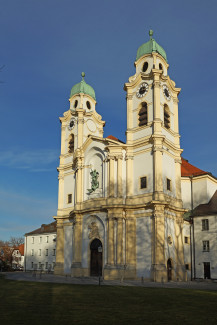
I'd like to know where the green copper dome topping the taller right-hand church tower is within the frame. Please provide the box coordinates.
[136,30,167,62]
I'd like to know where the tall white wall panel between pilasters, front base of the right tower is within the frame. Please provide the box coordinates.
[136,217,152,279]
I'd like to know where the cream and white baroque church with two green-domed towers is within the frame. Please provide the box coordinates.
[54,30,217,282]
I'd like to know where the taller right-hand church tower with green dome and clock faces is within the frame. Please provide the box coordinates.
[124,30,184,281]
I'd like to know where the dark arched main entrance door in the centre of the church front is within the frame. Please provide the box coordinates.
[90,239,102,276]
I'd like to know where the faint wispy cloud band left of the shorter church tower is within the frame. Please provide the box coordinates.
[0,149,59,172]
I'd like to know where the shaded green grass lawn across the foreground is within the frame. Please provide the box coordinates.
[0,277,217,325]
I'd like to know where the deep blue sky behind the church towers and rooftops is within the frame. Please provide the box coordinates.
[0,0,217,240]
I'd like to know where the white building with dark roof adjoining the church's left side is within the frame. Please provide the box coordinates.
[24,222,57,272]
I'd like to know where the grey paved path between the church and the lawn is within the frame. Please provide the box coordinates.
[2,272,217,291]
